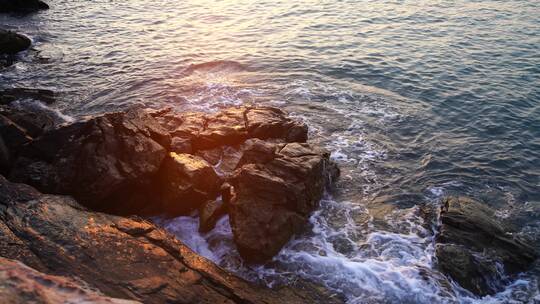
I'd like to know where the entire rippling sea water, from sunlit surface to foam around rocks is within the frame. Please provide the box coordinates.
[0,0,540,303]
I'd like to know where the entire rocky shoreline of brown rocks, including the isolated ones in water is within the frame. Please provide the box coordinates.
[0,0,537,303]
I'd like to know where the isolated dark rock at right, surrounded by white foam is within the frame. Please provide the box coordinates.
[436,197,537,296]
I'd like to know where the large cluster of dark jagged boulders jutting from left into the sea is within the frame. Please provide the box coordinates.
[4,106,339,262]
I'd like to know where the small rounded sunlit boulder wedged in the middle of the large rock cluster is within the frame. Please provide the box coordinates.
[156,152,221,215]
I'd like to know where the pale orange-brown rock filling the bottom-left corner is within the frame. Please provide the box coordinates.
[0,258,140,304]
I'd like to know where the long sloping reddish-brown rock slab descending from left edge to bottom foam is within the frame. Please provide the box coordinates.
[0,177,339,304]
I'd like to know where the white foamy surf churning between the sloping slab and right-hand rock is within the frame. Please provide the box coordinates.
[156,191,538,304]
